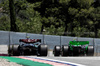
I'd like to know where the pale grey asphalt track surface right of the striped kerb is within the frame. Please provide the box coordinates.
[40,57,100,66]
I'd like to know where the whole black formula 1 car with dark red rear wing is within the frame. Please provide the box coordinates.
[8,38,48,56]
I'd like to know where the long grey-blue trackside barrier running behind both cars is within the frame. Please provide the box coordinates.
[0,31,100,55]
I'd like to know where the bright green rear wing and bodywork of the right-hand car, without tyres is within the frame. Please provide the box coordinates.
[69,41,89,50]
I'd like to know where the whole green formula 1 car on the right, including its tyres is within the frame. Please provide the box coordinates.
[53,41,94,56]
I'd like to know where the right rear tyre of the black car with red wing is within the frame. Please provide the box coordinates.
[38,44,48,56]
